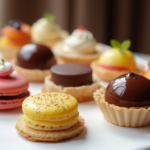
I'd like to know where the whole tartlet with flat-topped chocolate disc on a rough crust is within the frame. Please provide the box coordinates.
[42,63,100,102]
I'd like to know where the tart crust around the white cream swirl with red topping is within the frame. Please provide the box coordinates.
[52,41,104,66]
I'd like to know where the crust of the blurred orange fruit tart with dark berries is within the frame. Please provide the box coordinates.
[0,45,20,61]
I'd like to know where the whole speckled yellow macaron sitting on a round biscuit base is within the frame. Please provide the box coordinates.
[22,92,79,130]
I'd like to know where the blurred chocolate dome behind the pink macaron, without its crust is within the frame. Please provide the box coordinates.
[16,43,56,70]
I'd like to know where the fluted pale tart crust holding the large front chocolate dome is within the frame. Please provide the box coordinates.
[93,87,150,128]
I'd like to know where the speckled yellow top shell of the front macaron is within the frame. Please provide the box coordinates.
[22,92,78,121]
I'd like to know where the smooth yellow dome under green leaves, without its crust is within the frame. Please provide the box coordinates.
[98,48,137,70]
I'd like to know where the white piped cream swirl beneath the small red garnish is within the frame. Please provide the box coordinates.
[62,29,96,54]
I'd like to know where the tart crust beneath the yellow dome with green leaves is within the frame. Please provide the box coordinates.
[91,60,144,82]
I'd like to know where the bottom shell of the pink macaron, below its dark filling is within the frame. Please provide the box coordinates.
[0,92,30,110]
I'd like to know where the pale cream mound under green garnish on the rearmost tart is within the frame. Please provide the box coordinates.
[32,18,60,40]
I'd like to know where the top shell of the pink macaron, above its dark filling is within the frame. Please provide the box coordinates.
[0,74,29,96]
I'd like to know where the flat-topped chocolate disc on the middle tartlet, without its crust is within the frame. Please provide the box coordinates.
[51,63,92,87]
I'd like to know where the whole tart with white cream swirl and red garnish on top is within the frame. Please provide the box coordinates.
[52,26,103,65]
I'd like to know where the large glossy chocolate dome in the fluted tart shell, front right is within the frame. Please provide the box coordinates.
[105,72,150,107]
